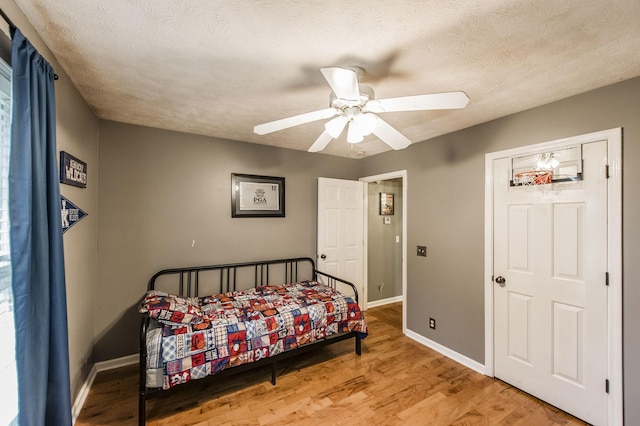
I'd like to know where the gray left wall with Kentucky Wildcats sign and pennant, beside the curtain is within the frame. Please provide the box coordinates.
[0,0,98,401]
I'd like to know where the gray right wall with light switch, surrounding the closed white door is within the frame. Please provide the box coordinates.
[362,78,640,425]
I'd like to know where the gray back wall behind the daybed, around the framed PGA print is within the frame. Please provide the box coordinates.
[95,121,359,361]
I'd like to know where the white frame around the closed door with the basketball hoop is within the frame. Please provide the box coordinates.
[484,128,623,425]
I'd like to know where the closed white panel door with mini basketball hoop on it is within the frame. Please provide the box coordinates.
[494,141,609,425]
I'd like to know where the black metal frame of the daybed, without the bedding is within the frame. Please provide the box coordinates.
[138,257,362,425]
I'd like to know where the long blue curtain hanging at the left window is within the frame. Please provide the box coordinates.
[9,29,71,426]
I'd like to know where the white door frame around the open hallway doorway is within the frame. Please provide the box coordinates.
[359,170,408,333]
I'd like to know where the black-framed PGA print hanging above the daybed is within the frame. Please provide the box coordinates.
[231,173,284,217]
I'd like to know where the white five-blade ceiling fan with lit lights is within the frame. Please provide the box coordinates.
[253,67,469,152]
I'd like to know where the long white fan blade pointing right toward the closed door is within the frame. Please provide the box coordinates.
[364,92,469,112]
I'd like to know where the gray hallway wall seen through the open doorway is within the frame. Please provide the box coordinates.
[367,179,402,302]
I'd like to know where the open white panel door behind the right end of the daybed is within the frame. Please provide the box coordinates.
[317,178,364,305]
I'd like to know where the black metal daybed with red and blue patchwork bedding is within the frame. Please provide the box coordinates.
[139,257,367,425]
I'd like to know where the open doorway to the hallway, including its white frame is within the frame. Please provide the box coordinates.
[360,170,407,332]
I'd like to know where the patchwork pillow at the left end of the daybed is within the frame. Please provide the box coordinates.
[140,291,202,325]
